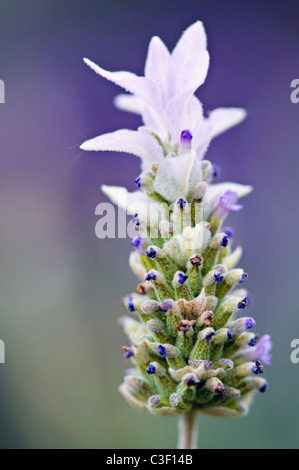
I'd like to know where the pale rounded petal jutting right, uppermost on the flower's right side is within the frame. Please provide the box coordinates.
[208,108,246,138]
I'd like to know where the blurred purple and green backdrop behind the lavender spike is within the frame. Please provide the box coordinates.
[0,0,299,449]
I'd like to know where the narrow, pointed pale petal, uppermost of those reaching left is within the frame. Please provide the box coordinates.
[83,59,161,109]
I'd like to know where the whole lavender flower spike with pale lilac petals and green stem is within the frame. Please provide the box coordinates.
[81,21,272,448]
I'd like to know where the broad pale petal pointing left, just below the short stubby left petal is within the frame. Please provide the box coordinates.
[80,129,163,163]
